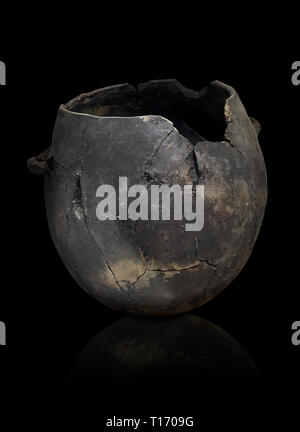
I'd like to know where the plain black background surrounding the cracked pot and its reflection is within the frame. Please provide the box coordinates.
[0,4,300,430]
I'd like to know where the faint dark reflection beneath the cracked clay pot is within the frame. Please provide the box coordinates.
[69,314,259,404]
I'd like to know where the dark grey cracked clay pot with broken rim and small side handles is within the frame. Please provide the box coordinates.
[29,80,267,315]
